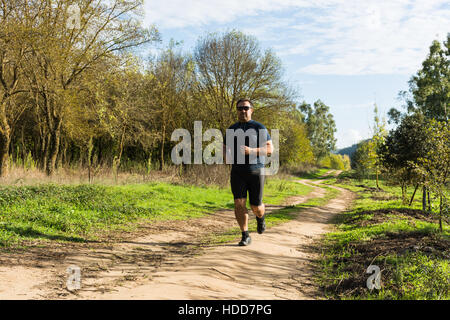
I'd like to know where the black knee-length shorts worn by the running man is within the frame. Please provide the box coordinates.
[230,169,264,206]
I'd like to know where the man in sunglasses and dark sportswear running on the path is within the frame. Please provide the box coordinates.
[224,99,273,246]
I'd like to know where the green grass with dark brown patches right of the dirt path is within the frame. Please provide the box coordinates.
[317,172,450,300]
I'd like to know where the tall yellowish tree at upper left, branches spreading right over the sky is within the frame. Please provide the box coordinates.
[24,0,158,175]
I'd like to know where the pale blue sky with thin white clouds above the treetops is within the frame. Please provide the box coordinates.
[144,0,450,148]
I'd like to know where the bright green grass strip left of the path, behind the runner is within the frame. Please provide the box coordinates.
[0,178,311,247]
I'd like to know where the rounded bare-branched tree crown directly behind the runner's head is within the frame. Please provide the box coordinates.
[194,30,292,132]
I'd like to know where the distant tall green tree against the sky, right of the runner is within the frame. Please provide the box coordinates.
[300,100,336,160]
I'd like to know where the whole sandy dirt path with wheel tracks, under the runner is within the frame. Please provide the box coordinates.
[0,174,353,299]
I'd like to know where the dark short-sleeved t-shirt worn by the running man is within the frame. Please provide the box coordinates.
[224,120,271,171]
